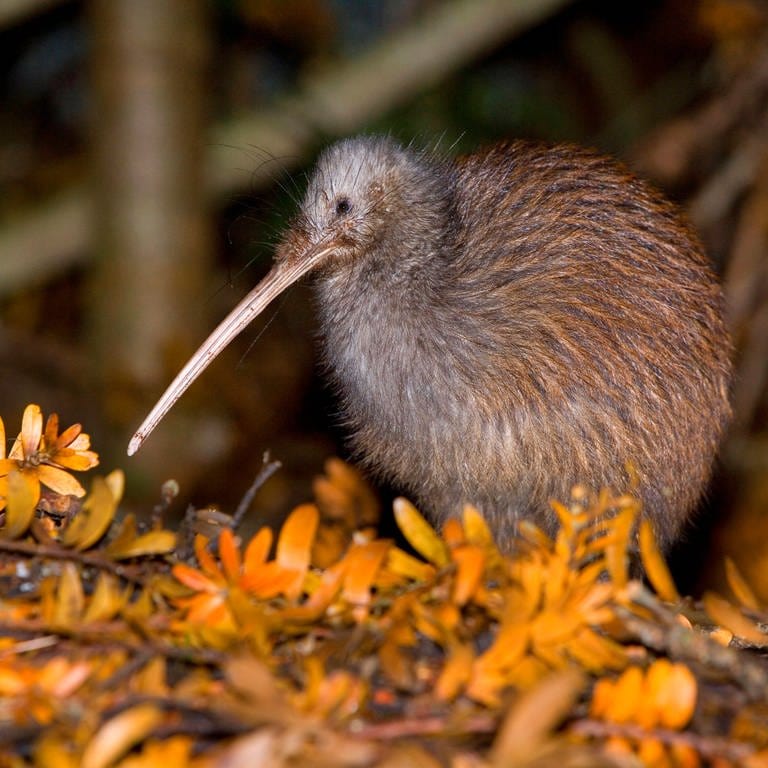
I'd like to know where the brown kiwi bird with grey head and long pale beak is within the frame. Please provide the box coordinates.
[129,137,731,546]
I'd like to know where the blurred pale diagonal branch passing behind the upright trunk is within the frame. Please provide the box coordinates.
[0,0,571,298]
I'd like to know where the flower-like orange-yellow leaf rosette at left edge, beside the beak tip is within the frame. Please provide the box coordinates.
[0,404,99,510]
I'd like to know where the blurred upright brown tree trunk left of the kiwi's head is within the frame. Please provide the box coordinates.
[88,0,210,396]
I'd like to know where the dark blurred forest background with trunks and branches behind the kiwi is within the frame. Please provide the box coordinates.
[0,0,768,599]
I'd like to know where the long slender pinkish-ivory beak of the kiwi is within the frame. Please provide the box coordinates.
[128,243,335,456]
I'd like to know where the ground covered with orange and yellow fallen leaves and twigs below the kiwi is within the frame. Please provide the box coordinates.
[0,406,768,768]
